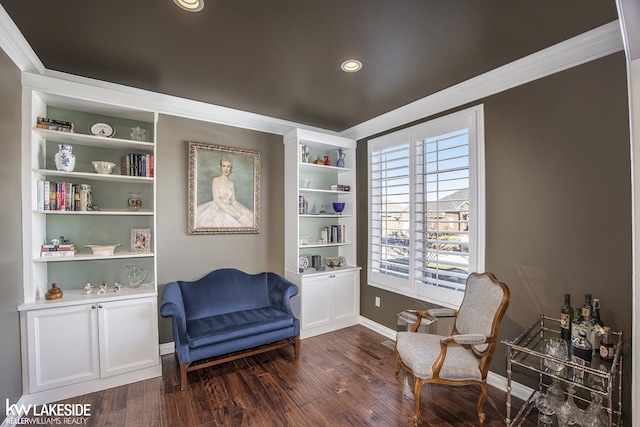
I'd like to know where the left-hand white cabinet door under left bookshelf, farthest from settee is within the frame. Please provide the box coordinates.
[26,305,100,393]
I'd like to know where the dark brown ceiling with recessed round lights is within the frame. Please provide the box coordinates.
[0,0,617,131]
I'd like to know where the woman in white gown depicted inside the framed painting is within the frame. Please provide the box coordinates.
[197,157,253,228]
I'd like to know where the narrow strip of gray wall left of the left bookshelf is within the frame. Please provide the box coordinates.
[0,49,23,412]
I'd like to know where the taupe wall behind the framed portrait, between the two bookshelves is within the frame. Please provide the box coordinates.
[156,115,284,343]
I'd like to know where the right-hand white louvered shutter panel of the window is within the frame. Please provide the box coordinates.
[414,128,470,293]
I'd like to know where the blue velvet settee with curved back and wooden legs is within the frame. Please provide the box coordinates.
[160,268,300,390]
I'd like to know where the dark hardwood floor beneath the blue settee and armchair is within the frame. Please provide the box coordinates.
[27,326,519,427]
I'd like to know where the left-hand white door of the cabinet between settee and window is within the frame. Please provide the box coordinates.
[300,275,333,330]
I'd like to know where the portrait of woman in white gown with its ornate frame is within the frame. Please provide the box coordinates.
[188,141,260,234]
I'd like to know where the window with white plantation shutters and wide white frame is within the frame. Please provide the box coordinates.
[368,106,484,307]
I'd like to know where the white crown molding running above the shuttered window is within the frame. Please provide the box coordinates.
[340,21,623,140]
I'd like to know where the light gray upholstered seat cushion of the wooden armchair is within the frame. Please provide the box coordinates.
[396,332,482,381]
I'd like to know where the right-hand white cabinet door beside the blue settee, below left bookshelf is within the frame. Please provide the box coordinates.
[98,297,160,378]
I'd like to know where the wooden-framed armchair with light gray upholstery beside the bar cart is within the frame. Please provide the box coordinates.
[396,273,509,425]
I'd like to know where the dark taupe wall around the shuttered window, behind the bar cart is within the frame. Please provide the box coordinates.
[357,52,632,418]
